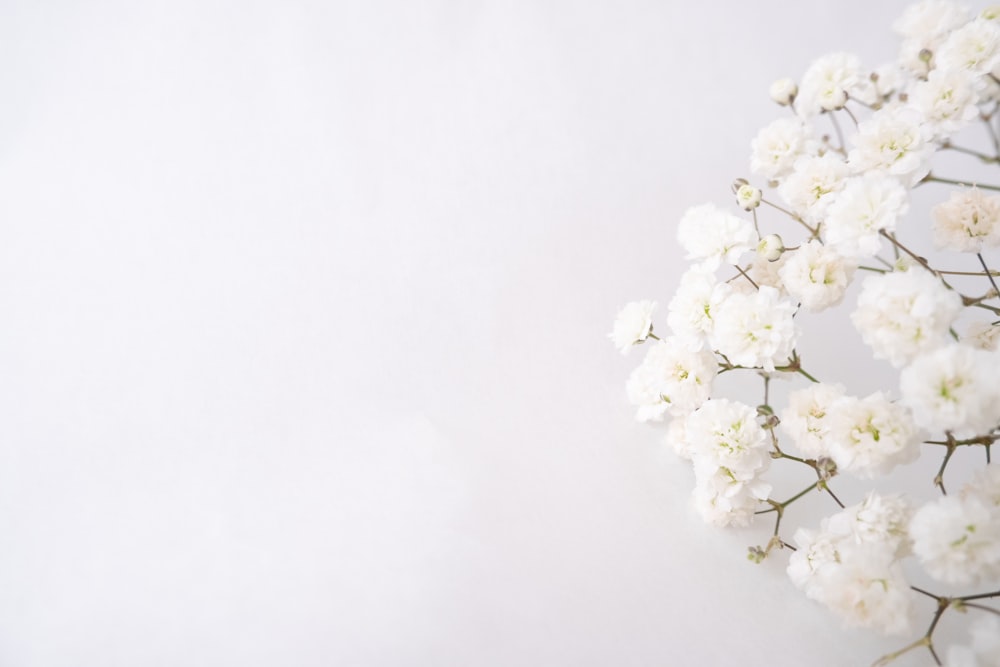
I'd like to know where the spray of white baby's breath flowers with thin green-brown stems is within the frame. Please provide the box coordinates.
[610,0,1000,666]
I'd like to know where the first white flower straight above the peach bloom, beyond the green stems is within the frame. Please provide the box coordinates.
[910,69,979,139]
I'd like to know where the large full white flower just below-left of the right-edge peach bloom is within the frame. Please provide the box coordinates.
[851,268,962,368]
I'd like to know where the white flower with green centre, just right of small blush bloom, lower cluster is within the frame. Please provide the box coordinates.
[826,392,920,478]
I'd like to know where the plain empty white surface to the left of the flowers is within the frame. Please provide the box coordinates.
[0,0,960,667]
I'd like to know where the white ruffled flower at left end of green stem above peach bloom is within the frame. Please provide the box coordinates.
[848,106,934,187]
